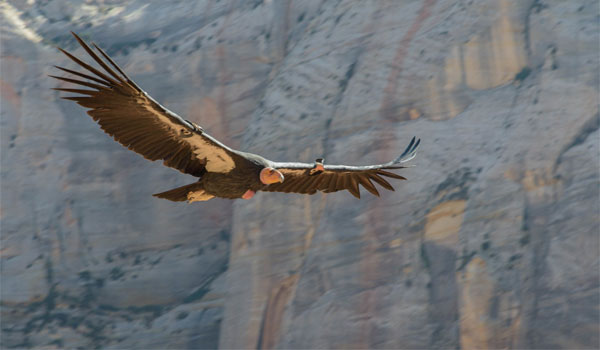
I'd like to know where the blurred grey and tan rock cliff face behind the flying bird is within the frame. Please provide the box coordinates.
[0,0,600,349]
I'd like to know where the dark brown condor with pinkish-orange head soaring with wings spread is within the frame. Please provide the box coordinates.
[50,32,420,202]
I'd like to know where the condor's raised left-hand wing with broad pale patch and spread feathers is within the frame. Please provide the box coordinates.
[51,33,239,176]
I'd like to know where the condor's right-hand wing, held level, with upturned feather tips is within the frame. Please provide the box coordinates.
[261,137,421,198]
